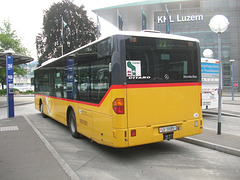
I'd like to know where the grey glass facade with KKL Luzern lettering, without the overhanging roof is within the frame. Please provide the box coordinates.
[154,0,240,89]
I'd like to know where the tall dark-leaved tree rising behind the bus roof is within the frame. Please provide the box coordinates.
[36,0,97,65]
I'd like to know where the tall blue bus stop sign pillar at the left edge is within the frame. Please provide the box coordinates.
[6,56,14,118]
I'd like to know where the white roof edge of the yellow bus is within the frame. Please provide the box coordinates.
[35,30,199,70]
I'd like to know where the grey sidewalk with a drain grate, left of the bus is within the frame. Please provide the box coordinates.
[0,116,69,180]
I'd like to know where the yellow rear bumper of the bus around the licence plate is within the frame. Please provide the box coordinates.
[113,118,203,148]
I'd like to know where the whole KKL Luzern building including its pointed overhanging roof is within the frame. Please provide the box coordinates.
[94,0,240,91]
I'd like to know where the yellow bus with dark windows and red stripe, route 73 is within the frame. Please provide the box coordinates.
[35,32,203,148]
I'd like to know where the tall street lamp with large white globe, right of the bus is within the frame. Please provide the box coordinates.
[209,15,229,135]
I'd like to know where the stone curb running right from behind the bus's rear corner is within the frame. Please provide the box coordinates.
[178,137,240,157]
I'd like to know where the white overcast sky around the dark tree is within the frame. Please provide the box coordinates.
[0,0,141,60]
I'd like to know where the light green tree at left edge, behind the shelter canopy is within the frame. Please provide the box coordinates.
[0,21,28,89]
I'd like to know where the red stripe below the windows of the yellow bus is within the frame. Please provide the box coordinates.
[36,82,202,107]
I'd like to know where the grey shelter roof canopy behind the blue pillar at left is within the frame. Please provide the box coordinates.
[0,53,33,67]
